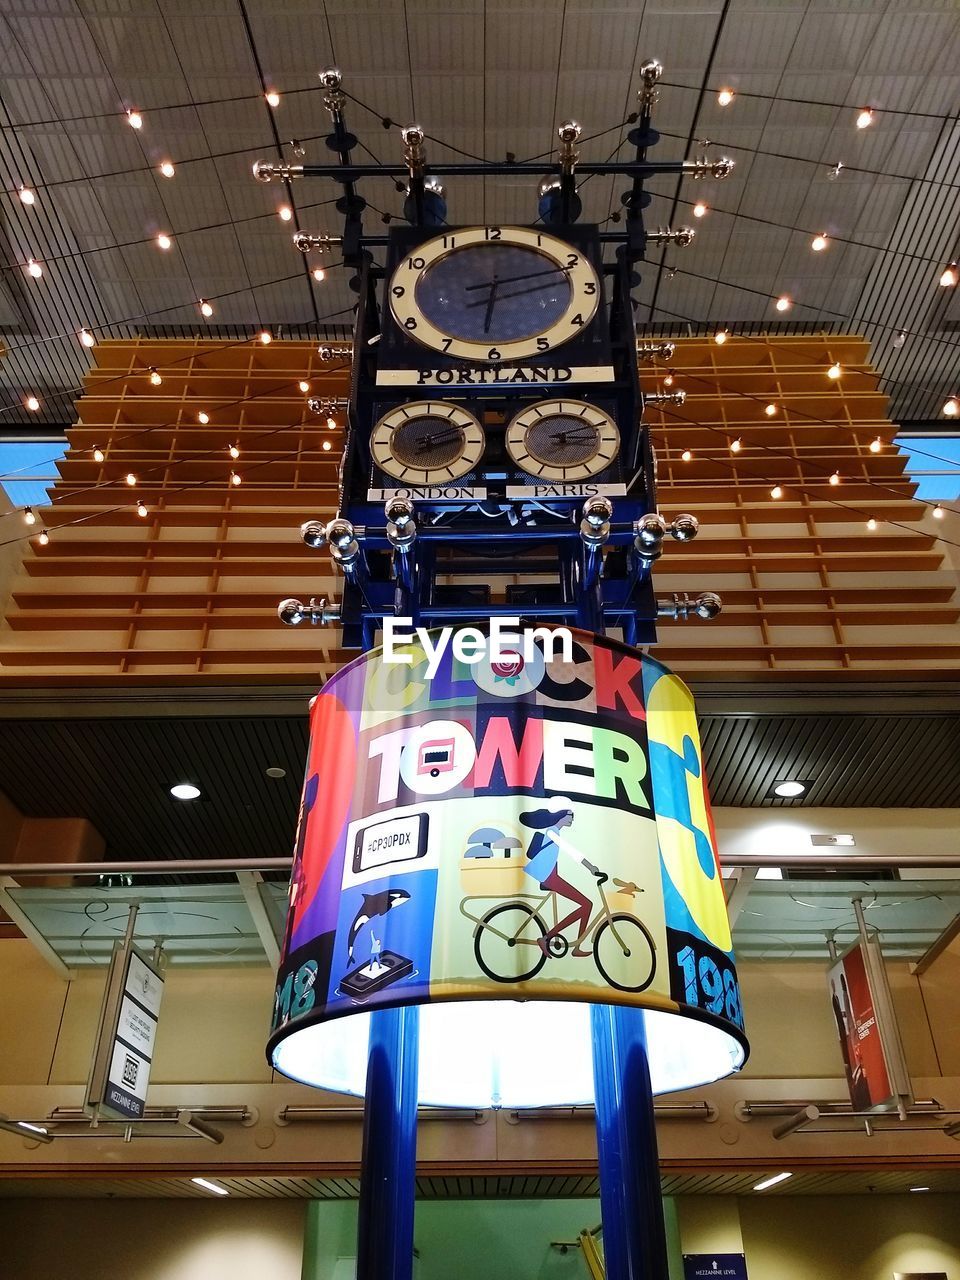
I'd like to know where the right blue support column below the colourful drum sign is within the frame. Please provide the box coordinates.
[590,1005,669,1280]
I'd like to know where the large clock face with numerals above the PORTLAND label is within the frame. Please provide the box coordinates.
[389,227,600,364]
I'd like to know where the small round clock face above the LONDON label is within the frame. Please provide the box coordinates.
[370,401,484,484]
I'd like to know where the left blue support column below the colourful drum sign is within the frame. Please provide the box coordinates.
[357,1005,420,1280]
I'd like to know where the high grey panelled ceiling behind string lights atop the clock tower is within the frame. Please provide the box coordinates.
[0,0,960,431]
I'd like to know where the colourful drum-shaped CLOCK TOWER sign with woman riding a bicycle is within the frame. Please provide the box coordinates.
[269,631,746,1105]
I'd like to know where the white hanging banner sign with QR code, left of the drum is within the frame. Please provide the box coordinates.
[86,943,164,1120]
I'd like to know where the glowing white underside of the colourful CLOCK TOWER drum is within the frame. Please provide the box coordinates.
[273,1000,745,1108]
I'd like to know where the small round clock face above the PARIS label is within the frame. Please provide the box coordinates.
[507,401,620,484]
